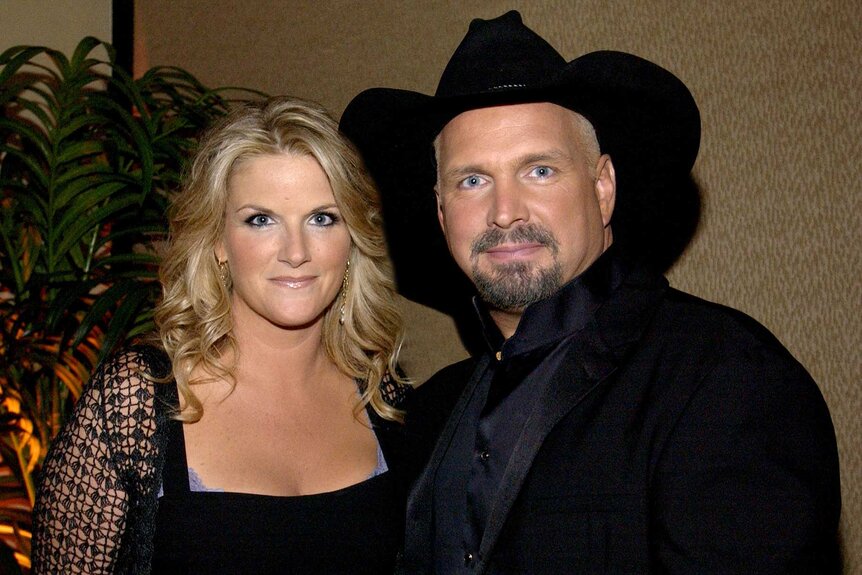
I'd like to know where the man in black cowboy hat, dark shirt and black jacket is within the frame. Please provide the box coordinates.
[342,12,840,573]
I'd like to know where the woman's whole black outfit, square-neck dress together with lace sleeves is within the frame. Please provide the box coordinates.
[32,346,410,575]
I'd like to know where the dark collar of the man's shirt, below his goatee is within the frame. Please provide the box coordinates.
[473,246,628,356]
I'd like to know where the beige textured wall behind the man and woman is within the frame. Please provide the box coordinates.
[6,0,862,573]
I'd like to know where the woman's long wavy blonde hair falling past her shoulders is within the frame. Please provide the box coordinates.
[155,96,408,422]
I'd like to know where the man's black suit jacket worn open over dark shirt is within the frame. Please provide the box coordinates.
[402,270,840,574]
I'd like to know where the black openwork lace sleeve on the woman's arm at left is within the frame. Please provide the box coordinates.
[32,350,169,574]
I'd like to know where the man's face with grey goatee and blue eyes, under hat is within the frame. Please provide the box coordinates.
[436,103,616,315]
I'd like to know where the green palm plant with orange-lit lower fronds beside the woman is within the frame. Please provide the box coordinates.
[0,38,260,566]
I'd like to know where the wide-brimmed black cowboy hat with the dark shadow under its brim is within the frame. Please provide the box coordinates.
[340,11,700,312]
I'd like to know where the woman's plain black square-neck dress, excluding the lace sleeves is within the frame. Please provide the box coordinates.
[152,390,403,575]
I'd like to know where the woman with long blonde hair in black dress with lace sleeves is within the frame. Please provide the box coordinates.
[33,98,408,573]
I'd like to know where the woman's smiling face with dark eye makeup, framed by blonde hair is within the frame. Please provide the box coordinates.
[216,153,350,328]
